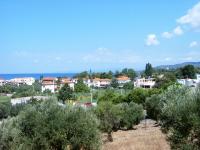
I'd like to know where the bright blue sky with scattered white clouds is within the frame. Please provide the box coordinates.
[0,0,200,73]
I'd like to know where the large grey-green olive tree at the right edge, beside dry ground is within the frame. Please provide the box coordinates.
[146,85,200,150]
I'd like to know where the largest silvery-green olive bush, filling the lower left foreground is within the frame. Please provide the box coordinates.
[0,100,100,150]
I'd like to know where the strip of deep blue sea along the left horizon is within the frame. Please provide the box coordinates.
[0,73,77,80]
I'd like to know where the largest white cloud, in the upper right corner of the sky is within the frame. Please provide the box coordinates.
[177,2,200,28]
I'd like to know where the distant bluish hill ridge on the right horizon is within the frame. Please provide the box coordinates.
[155,62,200,69]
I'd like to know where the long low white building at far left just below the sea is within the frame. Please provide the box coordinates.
[9,77,35,86]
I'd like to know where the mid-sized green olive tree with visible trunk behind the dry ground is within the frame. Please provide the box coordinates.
[95,101,143,141]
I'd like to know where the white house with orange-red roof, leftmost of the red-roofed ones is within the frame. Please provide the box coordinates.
[42,77,57,93]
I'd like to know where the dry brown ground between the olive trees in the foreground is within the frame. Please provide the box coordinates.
[102,120,170,150]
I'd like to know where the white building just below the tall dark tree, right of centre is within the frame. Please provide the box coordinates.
[134,78,156,88]
